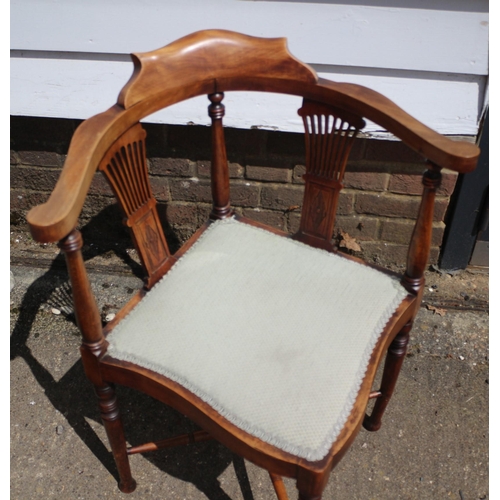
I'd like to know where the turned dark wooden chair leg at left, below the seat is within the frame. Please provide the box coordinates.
[95,384,136,493]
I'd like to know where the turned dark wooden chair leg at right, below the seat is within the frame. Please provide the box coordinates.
[363,321,413,431]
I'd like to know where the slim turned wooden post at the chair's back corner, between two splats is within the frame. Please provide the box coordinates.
[208,92,232,219]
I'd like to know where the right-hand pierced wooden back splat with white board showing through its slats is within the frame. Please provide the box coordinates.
[295,99,365,249]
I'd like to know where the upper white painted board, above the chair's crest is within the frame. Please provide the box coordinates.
[11,0,488,75]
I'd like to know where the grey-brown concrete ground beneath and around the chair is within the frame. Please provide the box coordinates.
[10,241,489,500]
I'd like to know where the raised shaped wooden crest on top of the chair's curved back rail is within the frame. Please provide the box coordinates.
[118,30,318,109]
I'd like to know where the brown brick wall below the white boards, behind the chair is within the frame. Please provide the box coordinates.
[11,118,456,266]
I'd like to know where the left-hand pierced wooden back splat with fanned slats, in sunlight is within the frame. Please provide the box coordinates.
[99,124,170,287]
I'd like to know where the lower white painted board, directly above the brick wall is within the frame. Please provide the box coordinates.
[11,58,484,135]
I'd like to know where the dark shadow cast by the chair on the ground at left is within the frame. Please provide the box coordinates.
[10,206,253,500]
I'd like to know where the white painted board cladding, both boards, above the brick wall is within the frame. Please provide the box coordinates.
[11,0,488,135]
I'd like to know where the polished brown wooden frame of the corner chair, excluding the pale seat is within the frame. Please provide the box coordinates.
[28,30,479,500]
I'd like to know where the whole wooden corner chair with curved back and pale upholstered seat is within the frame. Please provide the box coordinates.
[28,30,479,500]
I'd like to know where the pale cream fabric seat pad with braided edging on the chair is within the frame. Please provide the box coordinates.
[108,219,406,460]
